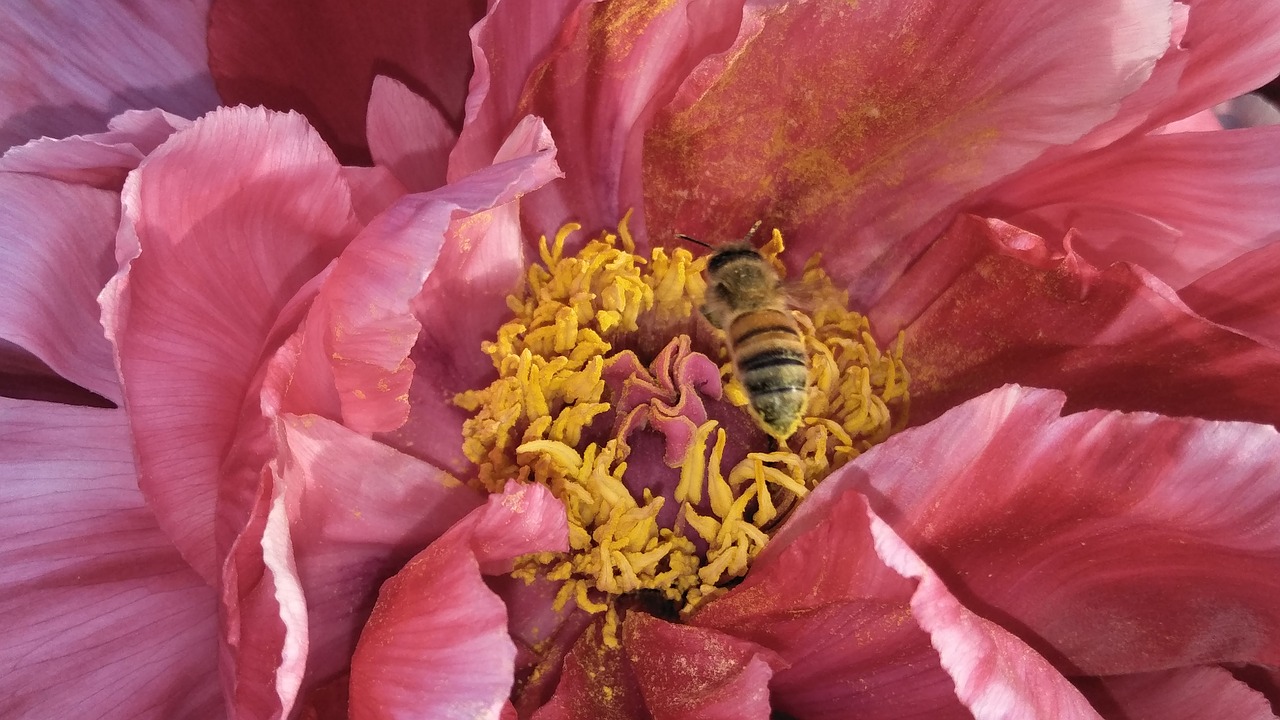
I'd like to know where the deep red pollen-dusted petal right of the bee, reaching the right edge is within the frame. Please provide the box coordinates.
[872,217,1280,424]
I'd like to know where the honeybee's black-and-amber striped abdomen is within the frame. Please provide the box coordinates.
[726,309,809,438]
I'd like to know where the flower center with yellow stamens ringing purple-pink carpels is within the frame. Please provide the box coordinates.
[456,214,909,641]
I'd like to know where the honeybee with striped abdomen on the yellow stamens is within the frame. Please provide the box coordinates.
[676,222,809,443]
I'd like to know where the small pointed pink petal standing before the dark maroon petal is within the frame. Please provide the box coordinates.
[365,76,458,192]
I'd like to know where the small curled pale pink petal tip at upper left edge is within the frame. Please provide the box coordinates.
[0,109,191,192]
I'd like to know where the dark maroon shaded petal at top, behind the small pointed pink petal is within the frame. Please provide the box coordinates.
[209,0,484,164]
